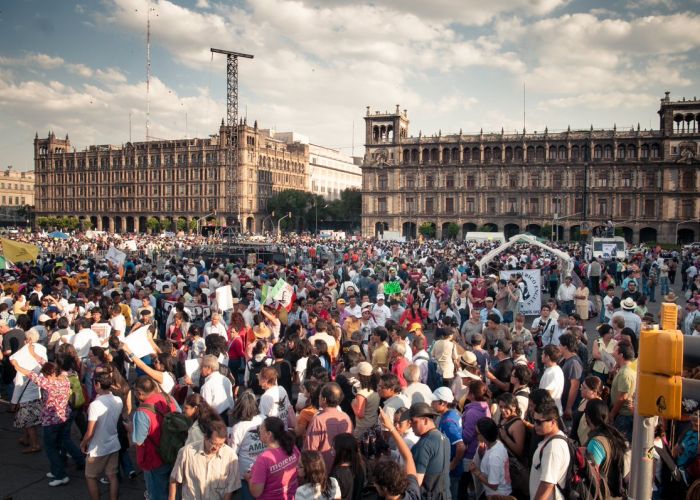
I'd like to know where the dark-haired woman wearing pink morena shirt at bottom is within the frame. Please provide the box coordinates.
[244,417,300,500]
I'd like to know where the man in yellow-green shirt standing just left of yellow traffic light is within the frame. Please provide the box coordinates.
[609,340,637,442]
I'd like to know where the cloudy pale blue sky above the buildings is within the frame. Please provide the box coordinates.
[0,0,700,170]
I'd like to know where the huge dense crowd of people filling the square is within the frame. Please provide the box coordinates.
[0,230,700,500]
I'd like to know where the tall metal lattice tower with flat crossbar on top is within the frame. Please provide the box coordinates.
[211,48,253,226]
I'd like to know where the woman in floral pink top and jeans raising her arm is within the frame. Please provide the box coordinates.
[12,352,76,486]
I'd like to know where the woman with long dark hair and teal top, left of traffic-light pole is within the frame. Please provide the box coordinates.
[585,399,629,498]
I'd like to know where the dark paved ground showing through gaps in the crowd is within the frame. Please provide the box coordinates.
[0,280,682,500]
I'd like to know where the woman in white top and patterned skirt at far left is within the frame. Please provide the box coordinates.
[12,329,46,453]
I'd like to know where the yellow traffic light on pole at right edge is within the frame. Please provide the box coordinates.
[637,303,685,419]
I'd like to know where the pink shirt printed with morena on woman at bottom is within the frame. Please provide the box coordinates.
[250,447,301,500]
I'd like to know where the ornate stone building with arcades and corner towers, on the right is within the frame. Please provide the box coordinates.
[362,92,700,243]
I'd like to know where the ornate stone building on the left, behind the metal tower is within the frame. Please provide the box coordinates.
[34,122,309,232]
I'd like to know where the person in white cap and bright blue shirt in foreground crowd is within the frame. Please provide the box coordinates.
[431,387,466,499]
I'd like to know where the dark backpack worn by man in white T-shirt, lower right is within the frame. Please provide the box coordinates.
[536,434,610,500]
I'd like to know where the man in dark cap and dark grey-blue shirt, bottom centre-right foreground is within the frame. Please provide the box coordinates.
[408,403,451,498]
